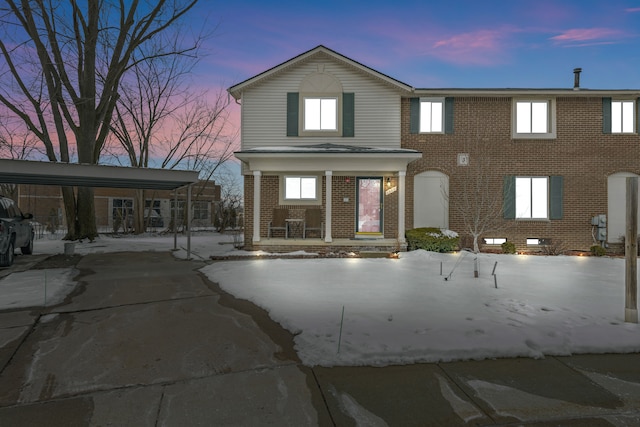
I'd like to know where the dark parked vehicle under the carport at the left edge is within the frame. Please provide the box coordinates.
[0,196,34,267]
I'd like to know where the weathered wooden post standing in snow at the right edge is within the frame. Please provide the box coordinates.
[624,177,638,323]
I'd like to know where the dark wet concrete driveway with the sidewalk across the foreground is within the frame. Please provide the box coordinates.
[0,252,640,426]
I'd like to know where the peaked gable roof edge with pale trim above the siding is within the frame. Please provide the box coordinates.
[227,45,413,99]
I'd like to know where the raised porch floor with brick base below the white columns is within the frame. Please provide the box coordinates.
[247,237,407,254]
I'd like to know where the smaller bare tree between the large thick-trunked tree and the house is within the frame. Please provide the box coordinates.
[109,48,237,233]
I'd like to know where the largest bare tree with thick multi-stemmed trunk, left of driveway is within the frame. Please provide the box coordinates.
[0,0,198,240]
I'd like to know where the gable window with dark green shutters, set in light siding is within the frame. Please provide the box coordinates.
[287,92,355,137]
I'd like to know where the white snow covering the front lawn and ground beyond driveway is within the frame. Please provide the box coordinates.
[0,233,640,366]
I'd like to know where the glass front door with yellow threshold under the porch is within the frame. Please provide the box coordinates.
[356,177,382,234]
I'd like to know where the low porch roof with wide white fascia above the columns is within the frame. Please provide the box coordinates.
[235,144,422,172]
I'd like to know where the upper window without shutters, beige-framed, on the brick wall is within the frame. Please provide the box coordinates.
[512,99,556,139]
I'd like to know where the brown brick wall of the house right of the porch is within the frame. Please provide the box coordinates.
[402,96,640,250]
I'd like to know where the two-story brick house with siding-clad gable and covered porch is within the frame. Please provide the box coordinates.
[229,46,640,251]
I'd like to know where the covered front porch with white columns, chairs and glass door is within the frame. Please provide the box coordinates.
[236,144,422,252]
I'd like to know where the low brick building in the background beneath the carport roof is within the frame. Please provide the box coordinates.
[17,181,220,233]
